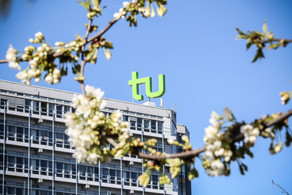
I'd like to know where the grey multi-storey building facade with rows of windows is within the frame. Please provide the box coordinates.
[0,80,191,195]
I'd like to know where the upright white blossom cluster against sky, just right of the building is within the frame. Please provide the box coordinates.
[203,112,233,176]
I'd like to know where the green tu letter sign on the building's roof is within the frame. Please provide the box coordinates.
[129,72,165,101]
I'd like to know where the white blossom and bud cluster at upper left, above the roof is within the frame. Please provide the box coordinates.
[6,32,85,84]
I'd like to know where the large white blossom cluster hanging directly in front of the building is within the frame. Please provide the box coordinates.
[65,86,129,164]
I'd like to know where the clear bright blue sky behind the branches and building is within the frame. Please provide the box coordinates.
[0,0,292,195]
